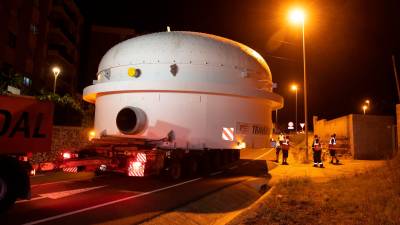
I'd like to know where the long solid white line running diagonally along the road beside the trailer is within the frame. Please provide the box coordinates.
[24,177,203,225]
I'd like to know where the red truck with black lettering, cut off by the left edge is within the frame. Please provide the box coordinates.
[0,96,53,212]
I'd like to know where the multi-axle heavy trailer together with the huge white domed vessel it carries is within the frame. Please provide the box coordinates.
[62,32,283,179]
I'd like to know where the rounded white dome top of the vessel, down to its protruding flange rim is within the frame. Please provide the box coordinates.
[84,31,283,107]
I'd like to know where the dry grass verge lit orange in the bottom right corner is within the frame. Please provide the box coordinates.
[234,155,400,225]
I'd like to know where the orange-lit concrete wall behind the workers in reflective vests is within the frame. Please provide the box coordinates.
[314,114,395,159]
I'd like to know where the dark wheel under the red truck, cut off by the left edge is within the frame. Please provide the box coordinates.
[0,173,17,212]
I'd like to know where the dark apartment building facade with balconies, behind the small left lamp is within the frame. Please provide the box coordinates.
[0,0,83,95]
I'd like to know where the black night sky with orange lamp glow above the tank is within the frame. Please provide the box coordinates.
[76,0,400,128]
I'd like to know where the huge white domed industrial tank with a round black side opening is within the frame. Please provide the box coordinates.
[83,32,283,149]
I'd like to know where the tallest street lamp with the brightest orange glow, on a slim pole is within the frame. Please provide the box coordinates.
[289,9,308,161]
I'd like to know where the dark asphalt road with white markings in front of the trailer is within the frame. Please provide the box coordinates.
[0,149,274,225]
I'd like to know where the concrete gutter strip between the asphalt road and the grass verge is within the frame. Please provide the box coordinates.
[142,177,267,225]
